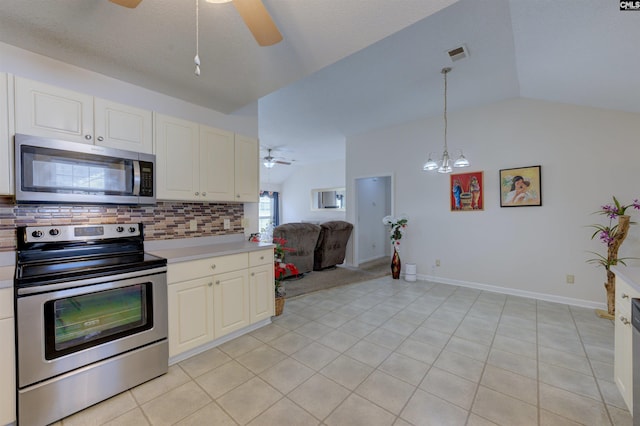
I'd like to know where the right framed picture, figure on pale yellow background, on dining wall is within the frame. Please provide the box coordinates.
[500,166,542,207]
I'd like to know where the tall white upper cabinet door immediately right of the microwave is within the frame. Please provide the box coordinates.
[155,114,201,200]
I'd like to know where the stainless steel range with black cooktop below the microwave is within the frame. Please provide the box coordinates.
[15,224,169,425]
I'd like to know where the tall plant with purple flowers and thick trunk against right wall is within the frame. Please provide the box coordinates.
[587,197,640,319]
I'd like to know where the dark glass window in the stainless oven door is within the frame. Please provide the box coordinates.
[44,283,153,359]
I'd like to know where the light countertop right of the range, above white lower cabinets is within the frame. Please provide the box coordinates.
[145,234,274,263]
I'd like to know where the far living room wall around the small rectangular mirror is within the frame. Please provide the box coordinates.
[281,160,350,223]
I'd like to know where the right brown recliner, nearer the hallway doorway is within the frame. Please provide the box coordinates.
[313,220,353,271]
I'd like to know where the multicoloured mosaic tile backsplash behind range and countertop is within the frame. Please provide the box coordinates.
[0,197,244,251]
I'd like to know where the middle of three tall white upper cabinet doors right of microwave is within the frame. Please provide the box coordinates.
[200,126,234,201]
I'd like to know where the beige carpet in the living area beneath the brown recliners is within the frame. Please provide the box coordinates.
[284,257,391,299]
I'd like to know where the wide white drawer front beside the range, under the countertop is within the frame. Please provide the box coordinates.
[167,253,249,284]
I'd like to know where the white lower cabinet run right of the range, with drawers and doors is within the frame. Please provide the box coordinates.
[167,249,274,357]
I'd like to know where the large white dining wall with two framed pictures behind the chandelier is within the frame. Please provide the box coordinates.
[346,99,640,307]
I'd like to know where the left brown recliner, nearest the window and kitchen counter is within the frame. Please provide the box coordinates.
[273,223,320,277]
